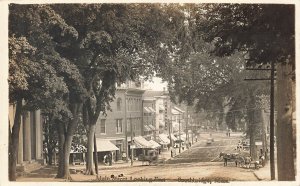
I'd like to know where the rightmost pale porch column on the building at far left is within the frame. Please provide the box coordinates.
[33,110,43,159]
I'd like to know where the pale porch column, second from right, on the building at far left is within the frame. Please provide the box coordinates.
[23,112,31,161]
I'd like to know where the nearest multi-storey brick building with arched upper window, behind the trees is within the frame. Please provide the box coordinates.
[96,81,145,161]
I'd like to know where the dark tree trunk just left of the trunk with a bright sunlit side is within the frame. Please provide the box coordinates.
[56,124,65,178]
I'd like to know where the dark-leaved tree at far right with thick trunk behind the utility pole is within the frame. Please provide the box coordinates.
[197,4,295,180]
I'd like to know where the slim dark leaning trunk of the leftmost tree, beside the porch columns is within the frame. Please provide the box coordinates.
[9,99,22,181]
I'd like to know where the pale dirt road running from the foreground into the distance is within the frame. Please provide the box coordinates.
[19,133,257,182]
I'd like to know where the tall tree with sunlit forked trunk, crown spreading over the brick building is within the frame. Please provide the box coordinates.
[53,4,188,174]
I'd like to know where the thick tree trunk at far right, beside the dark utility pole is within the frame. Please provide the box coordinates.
[277,64,295,181]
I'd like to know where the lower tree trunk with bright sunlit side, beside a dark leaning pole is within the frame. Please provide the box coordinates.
[85,125,96,175]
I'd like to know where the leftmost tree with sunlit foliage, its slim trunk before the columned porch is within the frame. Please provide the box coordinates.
[9,4,82,180]
